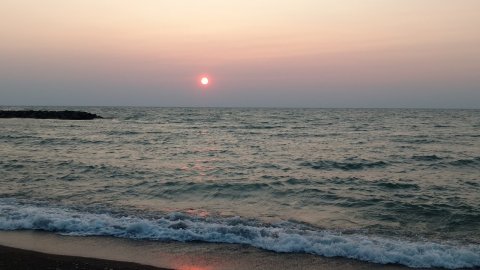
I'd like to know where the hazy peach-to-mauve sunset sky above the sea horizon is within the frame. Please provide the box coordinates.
[0,0,480,108]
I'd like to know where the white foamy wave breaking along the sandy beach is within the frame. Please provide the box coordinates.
[0,201,480,269]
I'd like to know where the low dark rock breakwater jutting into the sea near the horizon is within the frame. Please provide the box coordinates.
[0,110,103,120]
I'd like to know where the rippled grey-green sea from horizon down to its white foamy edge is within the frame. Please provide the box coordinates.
[0,107,480,268]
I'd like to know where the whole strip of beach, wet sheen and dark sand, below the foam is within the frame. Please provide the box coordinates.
[0,231,435,270]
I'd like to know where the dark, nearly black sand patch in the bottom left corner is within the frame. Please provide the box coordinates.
[0,246,169,270]
